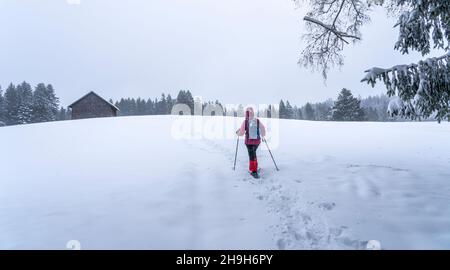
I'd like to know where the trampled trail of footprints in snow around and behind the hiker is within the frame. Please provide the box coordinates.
[195,139,367,249]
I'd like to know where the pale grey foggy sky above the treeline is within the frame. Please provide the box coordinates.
[0,0,440,106]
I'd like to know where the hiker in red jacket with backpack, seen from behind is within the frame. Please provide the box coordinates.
[236,107,266,178]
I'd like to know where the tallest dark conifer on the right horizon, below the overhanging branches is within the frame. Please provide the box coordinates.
[332,88,364,121]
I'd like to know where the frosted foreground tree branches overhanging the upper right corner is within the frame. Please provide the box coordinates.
[294,0,450,121]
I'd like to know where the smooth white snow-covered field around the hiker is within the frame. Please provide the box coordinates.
[0,116,450,249]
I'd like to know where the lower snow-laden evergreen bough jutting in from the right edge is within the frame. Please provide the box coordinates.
[361,52,450,121]
